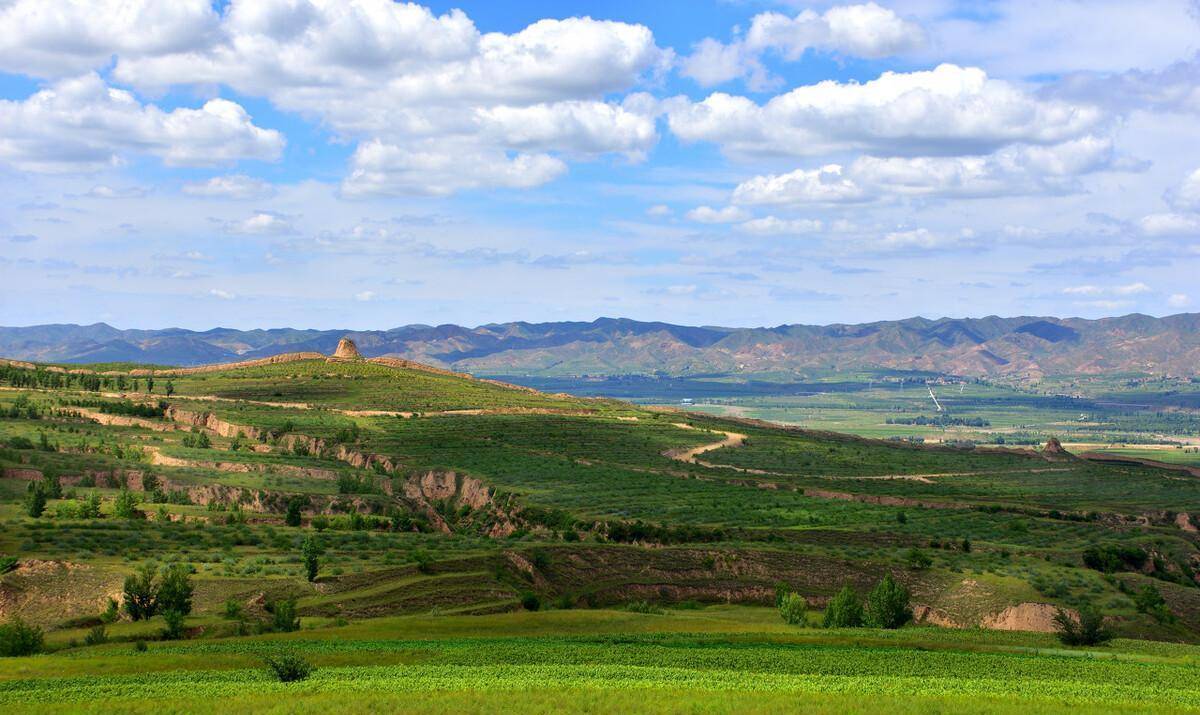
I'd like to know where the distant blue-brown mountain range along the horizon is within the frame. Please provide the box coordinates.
[0,313,1200,378]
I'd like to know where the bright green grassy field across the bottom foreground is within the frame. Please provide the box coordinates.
[0,607,1200,713]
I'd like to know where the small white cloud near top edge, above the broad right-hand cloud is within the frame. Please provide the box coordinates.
[680,2,925,89]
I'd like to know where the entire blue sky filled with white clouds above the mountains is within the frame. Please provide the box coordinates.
[0,0,1200,330]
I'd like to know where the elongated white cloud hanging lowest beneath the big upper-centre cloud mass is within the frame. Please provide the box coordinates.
[342,140,566,197]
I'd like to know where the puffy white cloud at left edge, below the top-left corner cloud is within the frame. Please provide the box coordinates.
[0,74,283,172]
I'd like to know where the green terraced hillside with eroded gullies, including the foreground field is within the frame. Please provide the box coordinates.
[0,354,1200,711]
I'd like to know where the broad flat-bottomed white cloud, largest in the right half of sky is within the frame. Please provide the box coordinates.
[665,65,1105,157]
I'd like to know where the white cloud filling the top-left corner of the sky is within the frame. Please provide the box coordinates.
[0,0,218,77]
